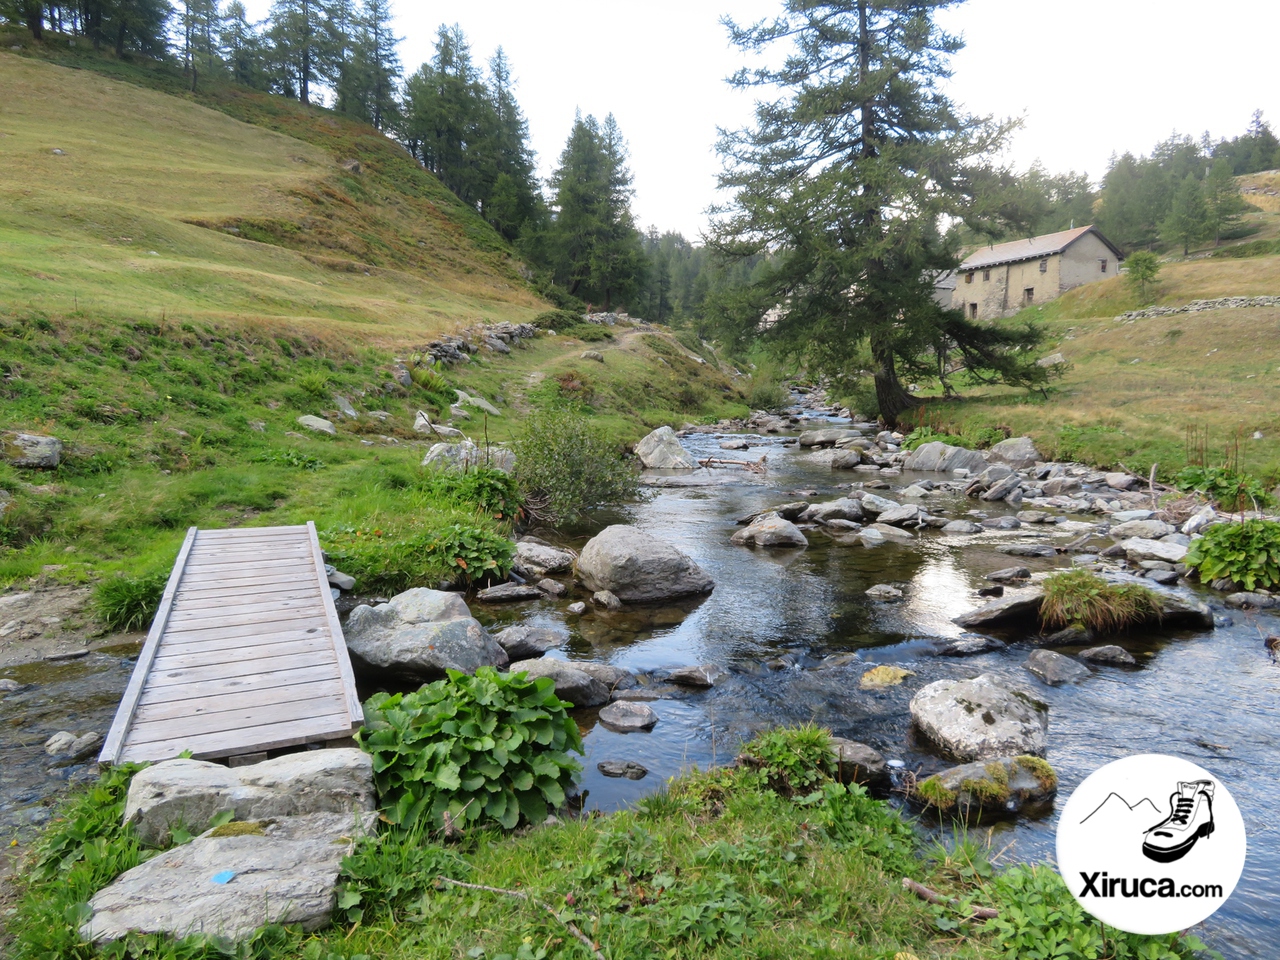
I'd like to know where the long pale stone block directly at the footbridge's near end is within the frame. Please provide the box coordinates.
[124,748,378,845]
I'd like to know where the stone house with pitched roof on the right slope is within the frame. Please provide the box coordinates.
[951,227,1124,320]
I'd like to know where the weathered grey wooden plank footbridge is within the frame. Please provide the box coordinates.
[99,524,364,764]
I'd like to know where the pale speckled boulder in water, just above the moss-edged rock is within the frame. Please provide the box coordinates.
[910,673,1048,760]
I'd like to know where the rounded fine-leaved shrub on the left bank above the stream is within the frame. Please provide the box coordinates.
[512,407,639,521]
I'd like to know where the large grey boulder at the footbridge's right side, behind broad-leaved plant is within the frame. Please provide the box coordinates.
[344,588,507,680]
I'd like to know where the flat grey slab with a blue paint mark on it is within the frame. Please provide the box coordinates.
[79,814,374,943]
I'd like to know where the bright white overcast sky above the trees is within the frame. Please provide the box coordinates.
[246,0,1280,239]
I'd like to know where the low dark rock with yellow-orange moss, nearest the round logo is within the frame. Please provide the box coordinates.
[911,755,1057,822]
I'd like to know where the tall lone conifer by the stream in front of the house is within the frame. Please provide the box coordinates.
[713,0,1043,424]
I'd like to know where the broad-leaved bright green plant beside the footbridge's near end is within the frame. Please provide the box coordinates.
[356,667,582,829]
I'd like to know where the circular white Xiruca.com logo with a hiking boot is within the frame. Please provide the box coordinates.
[1057,754,1245,934]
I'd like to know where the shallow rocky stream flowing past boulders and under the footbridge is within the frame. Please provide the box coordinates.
[0,421,1280,960]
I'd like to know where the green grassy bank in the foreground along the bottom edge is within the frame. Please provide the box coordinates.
[0,732,1197,960]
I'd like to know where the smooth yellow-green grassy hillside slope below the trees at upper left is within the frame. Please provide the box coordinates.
[0,52,544,343]
